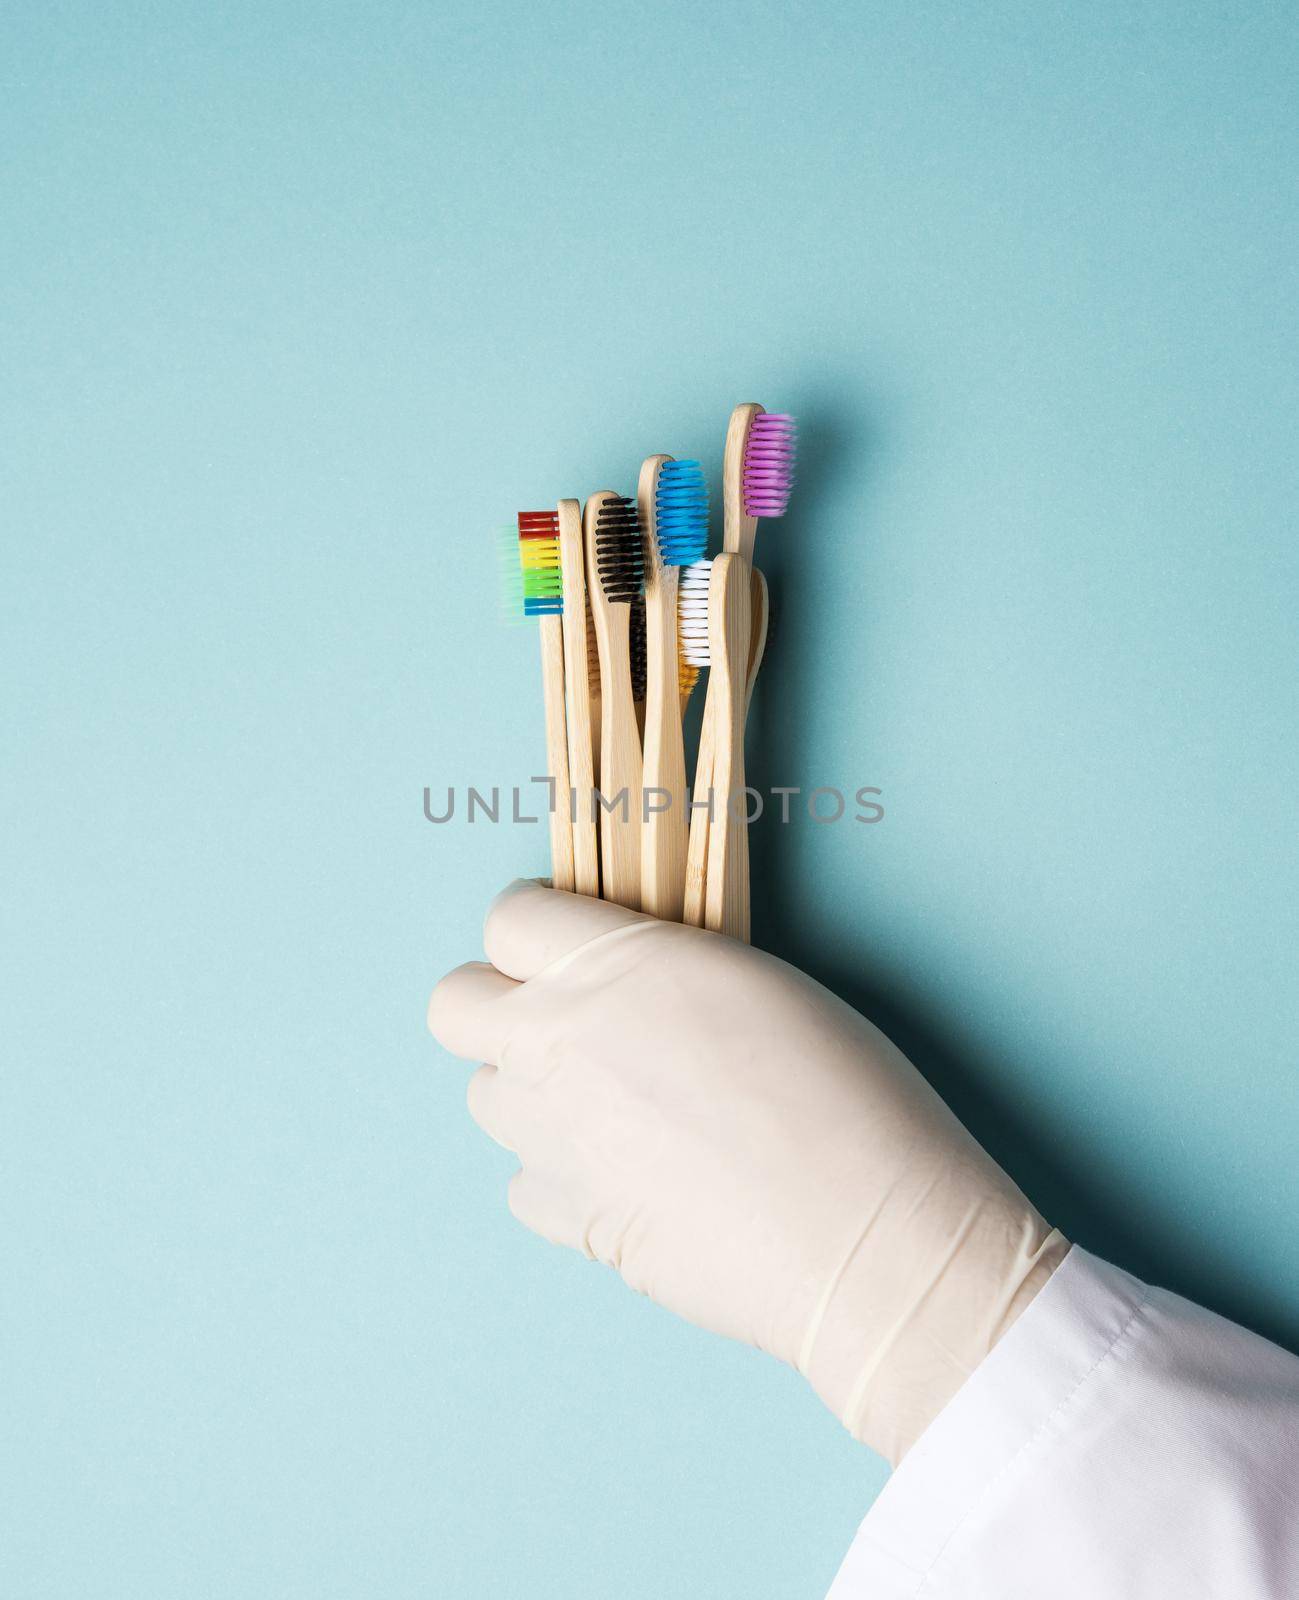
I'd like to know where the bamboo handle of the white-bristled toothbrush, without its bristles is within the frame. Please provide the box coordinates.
[704,555,750,941]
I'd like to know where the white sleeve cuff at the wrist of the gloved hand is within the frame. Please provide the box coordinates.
[827,1245,1299,1600]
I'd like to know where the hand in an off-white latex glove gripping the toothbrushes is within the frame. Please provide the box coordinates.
[429,882,1069,1462]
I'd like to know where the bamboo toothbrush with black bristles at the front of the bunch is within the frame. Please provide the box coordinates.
[584,490,645,910]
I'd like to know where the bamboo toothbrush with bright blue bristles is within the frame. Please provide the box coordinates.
[637,456,709,922]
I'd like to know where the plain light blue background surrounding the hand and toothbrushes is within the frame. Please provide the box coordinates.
[0,0,1299,1600]
